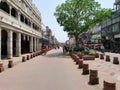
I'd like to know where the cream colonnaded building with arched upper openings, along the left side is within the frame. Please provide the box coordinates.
[0,0,42,59]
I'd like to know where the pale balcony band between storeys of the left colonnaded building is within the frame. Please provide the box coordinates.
[0,10,42,36]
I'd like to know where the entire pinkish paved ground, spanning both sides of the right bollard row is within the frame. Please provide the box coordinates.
[0,49,120,90]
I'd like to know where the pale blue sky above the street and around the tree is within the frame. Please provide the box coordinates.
[33,0,115,42]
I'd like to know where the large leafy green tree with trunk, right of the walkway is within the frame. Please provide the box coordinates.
[54,0,112,46]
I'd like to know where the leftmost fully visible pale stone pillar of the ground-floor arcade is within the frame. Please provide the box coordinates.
[7,30,13,59]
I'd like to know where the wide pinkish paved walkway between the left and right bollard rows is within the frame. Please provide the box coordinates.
[0,49,101,90]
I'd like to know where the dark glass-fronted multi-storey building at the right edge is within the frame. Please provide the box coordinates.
[101,0,120,52]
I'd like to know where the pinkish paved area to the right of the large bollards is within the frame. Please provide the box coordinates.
[84,52,120,90]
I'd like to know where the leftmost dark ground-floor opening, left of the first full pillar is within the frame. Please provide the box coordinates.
[1,30,8,59]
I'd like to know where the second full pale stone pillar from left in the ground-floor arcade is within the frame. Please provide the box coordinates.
[16,33,21,57]
